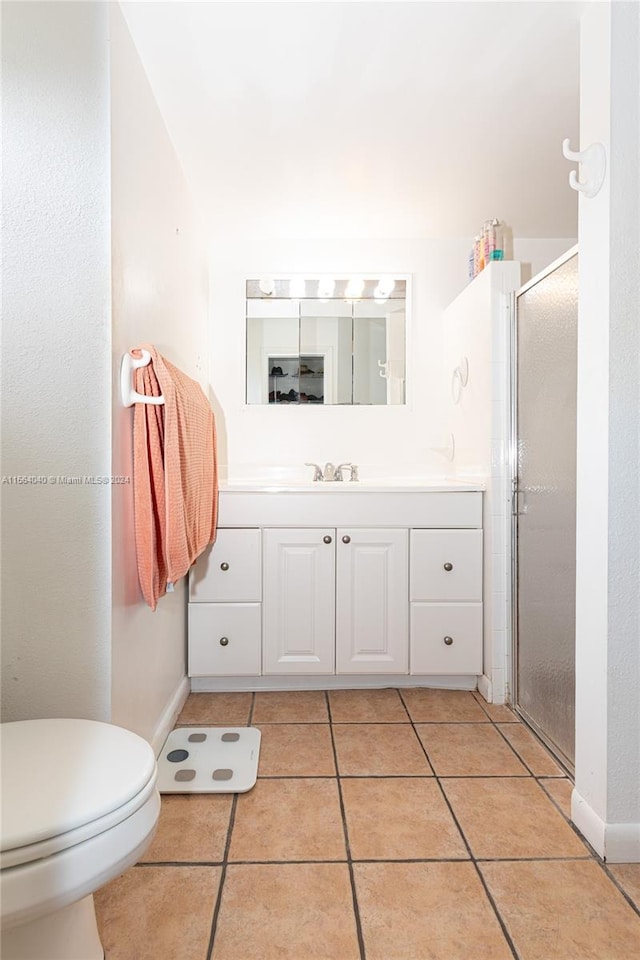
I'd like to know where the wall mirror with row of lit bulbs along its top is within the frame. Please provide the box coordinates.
[246,277,407,406]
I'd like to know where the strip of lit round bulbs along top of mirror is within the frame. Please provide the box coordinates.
[246,274,407,301]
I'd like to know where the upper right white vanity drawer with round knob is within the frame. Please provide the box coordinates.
[410,530,482,600]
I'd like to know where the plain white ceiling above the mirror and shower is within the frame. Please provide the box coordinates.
[121,0,584,238]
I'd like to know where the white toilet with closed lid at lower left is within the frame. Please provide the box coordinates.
[0,719,160,960]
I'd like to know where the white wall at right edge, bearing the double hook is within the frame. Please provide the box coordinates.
[572,3,640,860]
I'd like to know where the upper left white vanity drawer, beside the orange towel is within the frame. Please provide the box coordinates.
[189,529,262,603]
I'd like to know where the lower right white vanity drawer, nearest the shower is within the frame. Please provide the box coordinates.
[410,603,482,674]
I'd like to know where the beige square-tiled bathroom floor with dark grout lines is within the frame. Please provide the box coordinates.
[96,689,640,960]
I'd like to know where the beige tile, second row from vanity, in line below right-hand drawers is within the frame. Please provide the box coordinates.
[416,723,530,777]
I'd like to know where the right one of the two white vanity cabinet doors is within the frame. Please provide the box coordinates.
[336,529,409,673]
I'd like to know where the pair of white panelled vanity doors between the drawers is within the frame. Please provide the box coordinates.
[263,527,409,674]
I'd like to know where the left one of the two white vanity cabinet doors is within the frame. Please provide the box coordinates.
[262,528,335,674]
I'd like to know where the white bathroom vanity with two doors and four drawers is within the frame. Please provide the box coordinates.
[188,481,483,690]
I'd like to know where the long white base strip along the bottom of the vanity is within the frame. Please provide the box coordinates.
[188,674,478,688]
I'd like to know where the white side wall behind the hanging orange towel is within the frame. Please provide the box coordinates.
[111,4,208,745]
